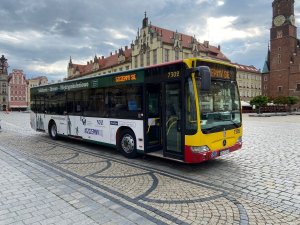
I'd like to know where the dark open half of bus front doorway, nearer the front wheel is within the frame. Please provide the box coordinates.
[145,83,163,152]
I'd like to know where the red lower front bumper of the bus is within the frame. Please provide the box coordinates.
[184,142,242,163]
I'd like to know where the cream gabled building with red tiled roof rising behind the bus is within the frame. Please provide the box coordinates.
[67,14,229,79]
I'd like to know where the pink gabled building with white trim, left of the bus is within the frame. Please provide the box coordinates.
[8,69,28,110]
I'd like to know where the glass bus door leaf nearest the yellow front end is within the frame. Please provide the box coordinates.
[163,81,183,159]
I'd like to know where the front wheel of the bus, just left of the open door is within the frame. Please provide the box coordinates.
[117,129,137,159]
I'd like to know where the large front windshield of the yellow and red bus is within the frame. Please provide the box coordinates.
[197,80,241,133]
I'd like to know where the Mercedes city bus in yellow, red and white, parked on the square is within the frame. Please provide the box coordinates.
[30,58,242,163]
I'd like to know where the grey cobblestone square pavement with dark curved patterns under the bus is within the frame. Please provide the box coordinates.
[0,112,300,225]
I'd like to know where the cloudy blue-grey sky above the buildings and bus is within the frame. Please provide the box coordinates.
[0,0,300,80]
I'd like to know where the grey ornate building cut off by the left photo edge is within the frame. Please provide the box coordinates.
[0,55,9,111]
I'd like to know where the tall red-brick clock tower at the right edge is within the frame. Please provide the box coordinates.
[262,0,300,107]
